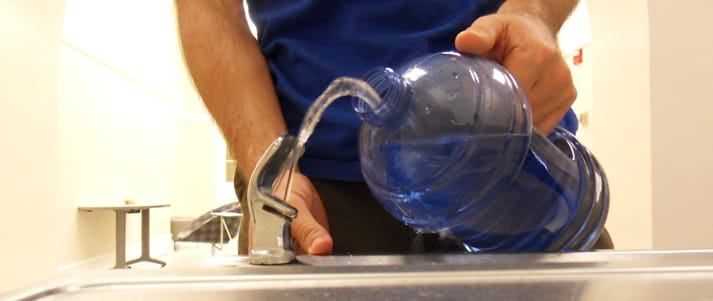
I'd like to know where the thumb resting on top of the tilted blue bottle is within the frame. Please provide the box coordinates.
[455,16,505,56]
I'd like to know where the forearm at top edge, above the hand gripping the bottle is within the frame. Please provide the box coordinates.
[498,0,579,35]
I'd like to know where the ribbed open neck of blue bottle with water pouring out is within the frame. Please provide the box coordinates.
[352,68,412,127]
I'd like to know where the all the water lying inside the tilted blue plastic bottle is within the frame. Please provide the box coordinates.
[365,134,579,252]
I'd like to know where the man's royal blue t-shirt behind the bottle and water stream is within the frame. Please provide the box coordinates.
[248,0,577,181]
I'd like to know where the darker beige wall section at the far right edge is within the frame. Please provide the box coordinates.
[648,0,713,249]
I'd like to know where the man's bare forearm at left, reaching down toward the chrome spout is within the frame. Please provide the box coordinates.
[176,0,287,176]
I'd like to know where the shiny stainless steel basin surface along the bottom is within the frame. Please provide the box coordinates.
[0,250,713,301]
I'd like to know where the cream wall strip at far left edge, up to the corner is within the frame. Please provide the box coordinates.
[0,0,64,291]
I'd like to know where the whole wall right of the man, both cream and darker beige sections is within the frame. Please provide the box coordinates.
[575,0,713,249]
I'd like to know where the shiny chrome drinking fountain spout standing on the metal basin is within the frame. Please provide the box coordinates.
[247,135,303,264]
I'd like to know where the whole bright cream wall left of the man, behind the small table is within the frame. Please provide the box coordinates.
[0,0,217,292]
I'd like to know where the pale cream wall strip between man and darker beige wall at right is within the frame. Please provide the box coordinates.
[585,0,653,249]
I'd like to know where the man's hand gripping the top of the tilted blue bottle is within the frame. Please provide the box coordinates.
[455,12,577,134]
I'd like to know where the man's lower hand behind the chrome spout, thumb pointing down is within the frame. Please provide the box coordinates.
[288,172,333,255]
